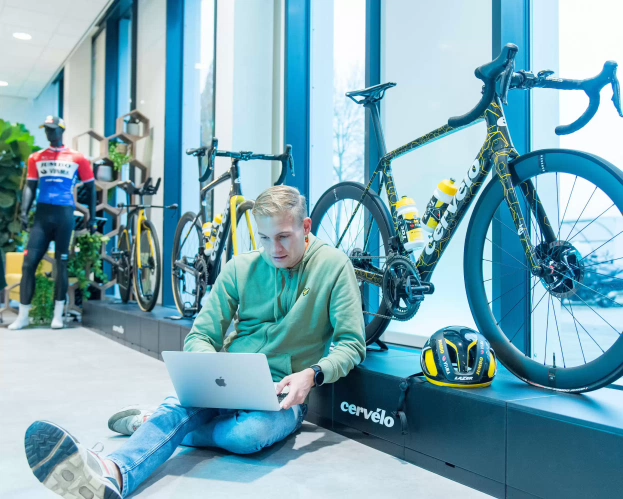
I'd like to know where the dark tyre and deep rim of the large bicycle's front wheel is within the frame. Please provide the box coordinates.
[464,149,623,393]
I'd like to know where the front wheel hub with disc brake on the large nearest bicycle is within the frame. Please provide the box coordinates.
[535,241,584,298]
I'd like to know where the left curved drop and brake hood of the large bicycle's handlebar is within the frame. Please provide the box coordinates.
[448,43,519,128]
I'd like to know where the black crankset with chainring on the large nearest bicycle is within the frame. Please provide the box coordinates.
[383,255,434,321]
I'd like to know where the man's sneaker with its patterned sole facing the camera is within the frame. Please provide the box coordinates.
[24,421,122,499]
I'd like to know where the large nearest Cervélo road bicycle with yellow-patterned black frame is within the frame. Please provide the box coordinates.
[312,44,623,392]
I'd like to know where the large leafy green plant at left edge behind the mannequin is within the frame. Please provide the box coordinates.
[0,120,40,253]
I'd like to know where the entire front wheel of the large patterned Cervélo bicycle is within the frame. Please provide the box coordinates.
[464,150,623,392]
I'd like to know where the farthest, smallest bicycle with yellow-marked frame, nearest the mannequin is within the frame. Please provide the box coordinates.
[111,178,177,312]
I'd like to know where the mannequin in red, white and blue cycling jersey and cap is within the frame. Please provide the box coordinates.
[9,116,97,330]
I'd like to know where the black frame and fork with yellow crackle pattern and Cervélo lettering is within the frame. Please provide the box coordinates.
[346,97,556,286]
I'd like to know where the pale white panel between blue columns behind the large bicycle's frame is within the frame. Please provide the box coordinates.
[381,0,492,345]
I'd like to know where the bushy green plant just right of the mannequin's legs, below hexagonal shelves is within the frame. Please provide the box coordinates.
[67,233,110,300]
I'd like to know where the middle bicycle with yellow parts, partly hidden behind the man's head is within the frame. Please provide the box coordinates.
[171,138,294,317]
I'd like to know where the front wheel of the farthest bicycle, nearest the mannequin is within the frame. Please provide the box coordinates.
[132,220,162,312]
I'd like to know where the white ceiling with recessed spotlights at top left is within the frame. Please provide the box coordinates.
[0,0,109,99]
